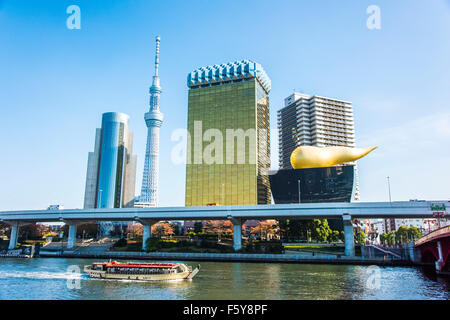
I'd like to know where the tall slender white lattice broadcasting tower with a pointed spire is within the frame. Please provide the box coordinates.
[139,36,164,206]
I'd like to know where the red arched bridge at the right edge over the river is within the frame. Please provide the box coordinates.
[414,226,450,275]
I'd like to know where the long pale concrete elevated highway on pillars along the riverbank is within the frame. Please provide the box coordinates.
[0,200,447,256]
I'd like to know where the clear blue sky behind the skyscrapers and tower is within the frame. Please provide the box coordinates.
[0,0,450,210]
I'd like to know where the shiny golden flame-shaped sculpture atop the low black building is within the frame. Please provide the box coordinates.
[291,146,378,169]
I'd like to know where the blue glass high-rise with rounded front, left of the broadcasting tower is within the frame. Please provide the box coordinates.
[84,112,136,208]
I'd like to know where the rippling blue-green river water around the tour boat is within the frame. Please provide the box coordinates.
[0,258,450,300]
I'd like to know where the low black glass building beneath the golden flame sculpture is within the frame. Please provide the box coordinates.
[269,165,354,204]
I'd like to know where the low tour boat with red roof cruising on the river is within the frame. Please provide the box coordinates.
[84,261,200,281]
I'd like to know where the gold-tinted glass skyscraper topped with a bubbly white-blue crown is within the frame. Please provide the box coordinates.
[186,60,271,206]
